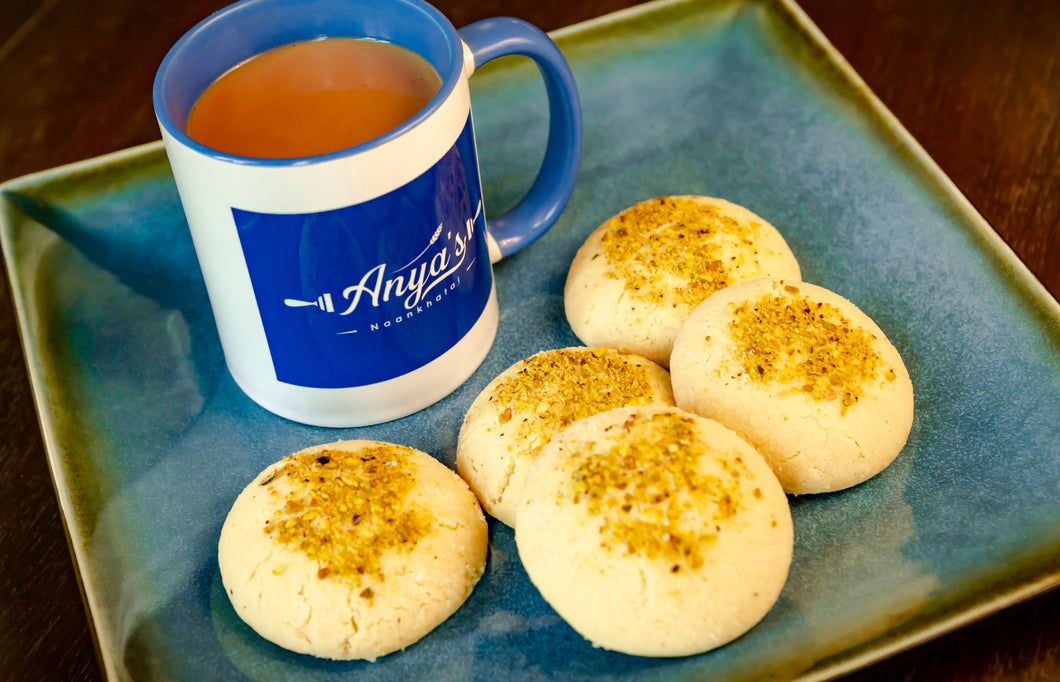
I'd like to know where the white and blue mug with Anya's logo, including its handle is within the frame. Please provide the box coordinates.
[153,0,582,426]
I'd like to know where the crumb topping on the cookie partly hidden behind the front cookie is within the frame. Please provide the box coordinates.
[491,348,655,450]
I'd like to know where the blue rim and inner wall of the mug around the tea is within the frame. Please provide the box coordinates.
[152,0,463,168]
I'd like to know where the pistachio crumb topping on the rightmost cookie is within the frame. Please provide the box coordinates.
[729,284,897,415]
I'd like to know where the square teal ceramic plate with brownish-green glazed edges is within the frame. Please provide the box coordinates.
[2,0,1060,681]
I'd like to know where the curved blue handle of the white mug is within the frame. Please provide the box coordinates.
[457,17,582,263]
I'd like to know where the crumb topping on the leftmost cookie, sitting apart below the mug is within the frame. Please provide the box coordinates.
[261,443,434,585]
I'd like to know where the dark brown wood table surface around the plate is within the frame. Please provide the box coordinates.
[0,0,1060,682]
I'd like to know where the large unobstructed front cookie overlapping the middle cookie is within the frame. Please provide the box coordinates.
[515,405,793,657]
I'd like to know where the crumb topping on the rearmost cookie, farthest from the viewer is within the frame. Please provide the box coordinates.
[601,196,762,305]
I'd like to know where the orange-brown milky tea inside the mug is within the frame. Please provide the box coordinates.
[187,37,442,158]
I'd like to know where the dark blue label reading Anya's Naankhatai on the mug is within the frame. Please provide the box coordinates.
[232,118,493,388]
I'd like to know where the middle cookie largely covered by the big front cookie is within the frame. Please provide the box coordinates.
[457,348,674,527]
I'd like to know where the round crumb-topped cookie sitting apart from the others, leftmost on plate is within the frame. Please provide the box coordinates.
[217,440,488,661]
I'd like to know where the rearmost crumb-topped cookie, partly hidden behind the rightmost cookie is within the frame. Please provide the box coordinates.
[564,196,801,367]
